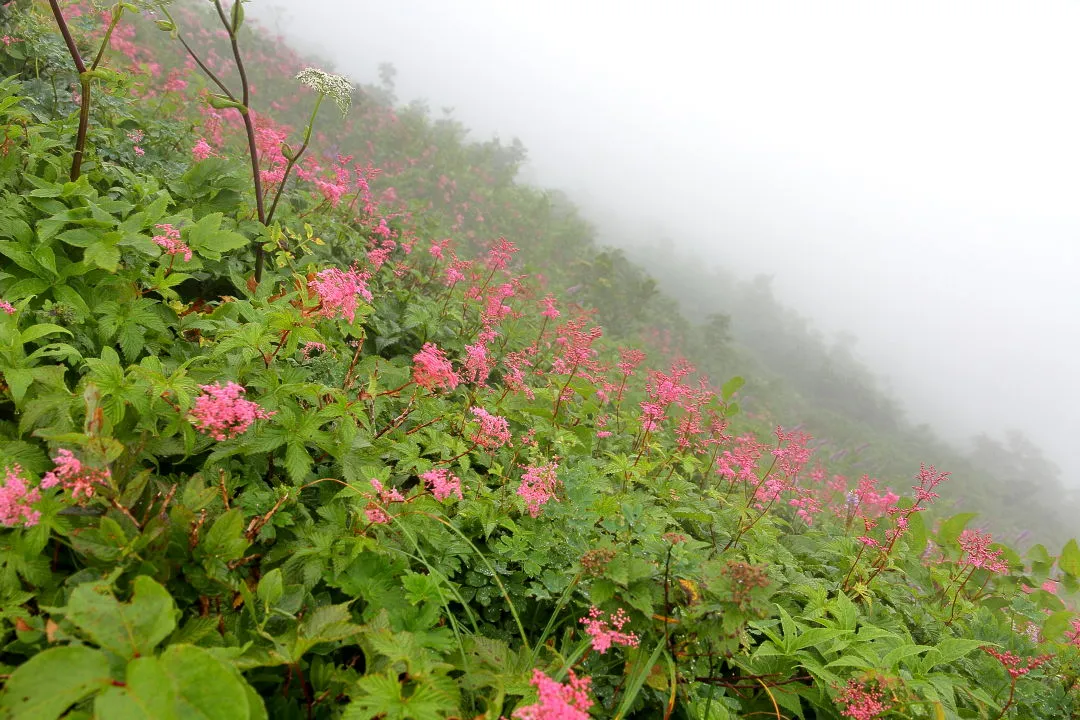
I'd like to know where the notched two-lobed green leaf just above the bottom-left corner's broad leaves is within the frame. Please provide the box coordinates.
[66,575,176,658]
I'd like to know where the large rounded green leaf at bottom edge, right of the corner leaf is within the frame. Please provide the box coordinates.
[94,644,252,720]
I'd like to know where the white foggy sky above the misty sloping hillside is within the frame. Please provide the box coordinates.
[249,0,1080,484]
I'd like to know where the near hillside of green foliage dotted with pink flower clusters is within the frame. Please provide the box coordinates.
[0,0,1080,720]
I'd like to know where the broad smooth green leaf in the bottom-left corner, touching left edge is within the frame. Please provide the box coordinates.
[0,646,112,720]
